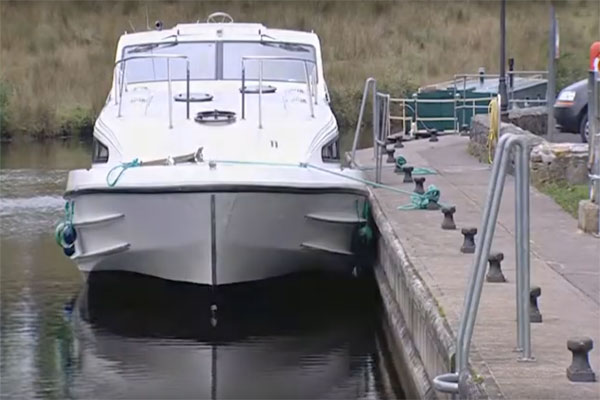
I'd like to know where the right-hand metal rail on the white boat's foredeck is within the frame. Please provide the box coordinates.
[241,56,319,129]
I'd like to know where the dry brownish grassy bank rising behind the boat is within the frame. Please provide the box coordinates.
[0,0,600,140]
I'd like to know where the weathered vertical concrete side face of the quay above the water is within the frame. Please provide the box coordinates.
[369,189,504,399]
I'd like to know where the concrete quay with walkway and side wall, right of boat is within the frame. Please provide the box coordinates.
[357,136,600,399]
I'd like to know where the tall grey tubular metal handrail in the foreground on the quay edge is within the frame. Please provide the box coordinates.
[433,134,533,397]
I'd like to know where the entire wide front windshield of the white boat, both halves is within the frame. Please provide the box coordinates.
[123,41,317,83]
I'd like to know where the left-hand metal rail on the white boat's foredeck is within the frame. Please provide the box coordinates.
[113,54,190,129]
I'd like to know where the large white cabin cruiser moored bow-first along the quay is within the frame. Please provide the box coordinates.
[63,13,366,286]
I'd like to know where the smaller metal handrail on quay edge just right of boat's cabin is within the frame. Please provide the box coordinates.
[350,77,390,183]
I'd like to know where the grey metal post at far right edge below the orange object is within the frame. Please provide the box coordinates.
[588,71,600,235]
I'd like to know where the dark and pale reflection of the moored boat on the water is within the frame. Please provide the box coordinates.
[68,272,402,399]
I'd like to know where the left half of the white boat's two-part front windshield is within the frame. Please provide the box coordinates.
[123,42,216,83]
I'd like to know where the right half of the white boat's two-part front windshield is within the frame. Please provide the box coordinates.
[223,40,317,82]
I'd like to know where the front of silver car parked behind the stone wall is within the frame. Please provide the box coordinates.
[554,79,589,143]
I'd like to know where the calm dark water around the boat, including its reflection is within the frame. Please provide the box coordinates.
[0,143,403,399]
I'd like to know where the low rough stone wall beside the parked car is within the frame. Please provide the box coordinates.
[468,115,588,184]
